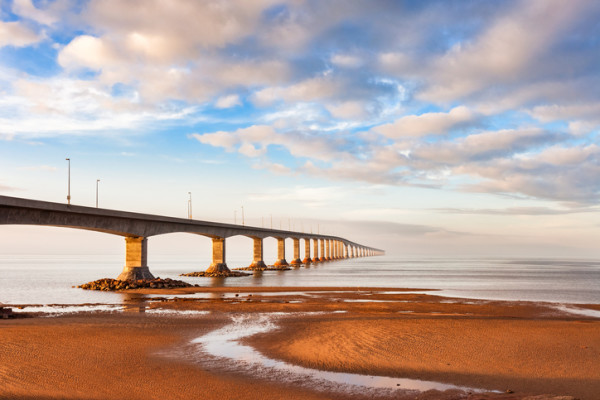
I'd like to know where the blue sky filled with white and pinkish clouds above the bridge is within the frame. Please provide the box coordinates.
[0,0,600,258]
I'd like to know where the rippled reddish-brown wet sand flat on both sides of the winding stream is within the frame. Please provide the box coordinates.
[0,288,600,400]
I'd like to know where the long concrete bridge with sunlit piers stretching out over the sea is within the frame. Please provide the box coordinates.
[0,196,384,280]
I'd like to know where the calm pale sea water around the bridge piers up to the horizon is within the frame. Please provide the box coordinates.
[0,255,600,304]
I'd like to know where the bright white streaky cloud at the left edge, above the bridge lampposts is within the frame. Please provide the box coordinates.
[0,74,195,138]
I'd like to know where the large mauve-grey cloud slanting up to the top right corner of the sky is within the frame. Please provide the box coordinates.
[418,0,591,103]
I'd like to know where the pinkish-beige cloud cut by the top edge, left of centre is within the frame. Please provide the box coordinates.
[85,0,274,51]
